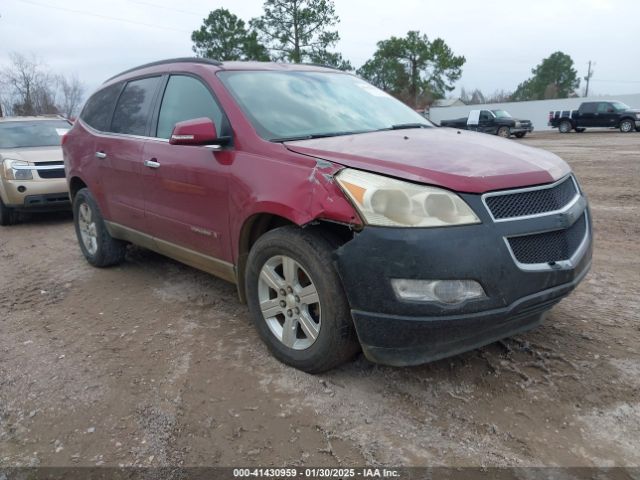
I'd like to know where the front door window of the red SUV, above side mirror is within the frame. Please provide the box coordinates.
[156,75,222,138]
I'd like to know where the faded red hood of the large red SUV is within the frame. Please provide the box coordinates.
[285,128,571,193]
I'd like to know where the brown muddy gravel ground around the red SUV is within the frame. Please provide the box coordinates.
[0,132,640,467]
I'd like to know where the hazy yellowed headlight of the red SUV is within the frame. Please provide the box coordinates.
[336,168,480,227]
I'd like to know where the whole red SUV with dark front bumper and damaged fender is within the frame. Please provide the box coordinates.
[63,58,591,372]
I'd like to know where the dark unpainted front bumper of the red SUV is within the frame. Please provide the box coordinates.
[336,189,592,366]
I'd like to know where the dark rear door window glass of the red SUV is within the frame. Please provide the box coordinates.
[111,77,160,135]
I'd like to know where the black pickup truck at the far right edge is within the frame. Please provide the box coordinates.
[548,102,640,133]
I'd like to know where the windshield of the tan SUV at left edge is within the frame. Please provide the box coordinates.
[0,120,71,148]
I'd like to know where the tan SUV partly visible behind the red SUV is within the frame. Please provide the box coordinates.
[0,116,71,225]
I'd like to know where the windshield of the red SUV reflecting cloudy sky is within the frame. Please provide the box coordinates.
[219,71,433,141]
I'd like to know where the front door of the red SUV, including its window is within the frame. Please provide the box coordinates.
[144,74,234,264]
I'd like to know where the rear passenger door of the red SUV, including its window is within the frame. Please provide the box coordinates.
[95,76,161,232]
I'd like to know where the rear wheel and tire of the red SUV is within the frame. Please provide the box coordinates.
[73,188,127,268]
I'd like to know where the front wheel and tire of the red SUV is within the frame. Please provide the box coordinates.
[246,226,358,373]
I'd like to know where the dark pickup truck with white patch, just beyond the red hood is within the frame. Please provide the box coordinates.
[440,110,533,138]
